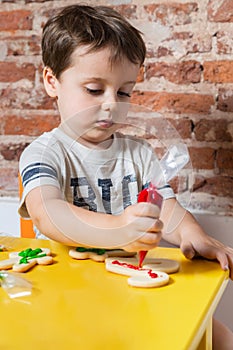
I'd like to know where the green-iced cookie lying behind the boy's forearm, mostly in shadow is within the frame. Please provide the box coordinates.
[69,247,135,262]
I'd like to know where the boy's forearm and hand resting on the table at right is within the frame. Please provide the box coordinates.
[160,198,233,279]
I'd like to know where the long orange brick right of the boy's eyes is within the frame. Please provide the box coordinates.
[132,91,215,114]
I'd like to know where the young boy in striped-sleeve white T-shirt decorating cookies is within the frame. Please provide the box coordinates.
[19,5,233,350]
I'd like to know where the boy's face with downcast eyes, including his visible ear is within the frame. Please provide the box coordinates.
[44,47,140,147]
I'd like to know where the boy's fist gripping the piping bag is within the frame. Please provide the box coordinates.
[120,202,163,252]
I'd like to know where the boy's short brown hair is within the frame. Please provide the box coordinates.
[42,5,146,79]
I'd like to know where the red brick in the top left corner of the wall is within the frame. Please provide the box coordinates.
[0,10,32,31]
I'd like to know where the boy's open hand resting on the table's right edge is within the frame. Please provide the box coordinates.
[180,235,233,280]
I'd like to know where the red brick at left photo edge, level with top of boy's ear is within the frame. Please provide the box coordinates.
[0,62,36,83]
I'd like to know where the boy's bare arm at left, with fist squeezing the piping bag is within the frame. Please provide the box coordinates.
[25,185,162,251]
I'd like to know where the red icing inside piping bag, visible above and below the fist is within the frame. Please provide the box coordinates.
[138,184,163,268]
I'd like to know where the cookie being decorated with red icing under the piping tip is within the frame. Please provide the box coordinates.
[105,258,169,288]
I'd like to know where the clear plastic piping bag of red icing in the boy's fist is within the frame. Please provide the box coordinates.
[138,144,189,268]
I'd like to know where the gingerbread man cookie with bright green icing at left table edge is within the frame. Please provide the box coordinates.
[0,248,53,272]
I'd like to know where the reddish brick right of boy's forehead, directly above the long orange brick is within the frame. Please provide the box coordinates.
[146,61,201,84]
